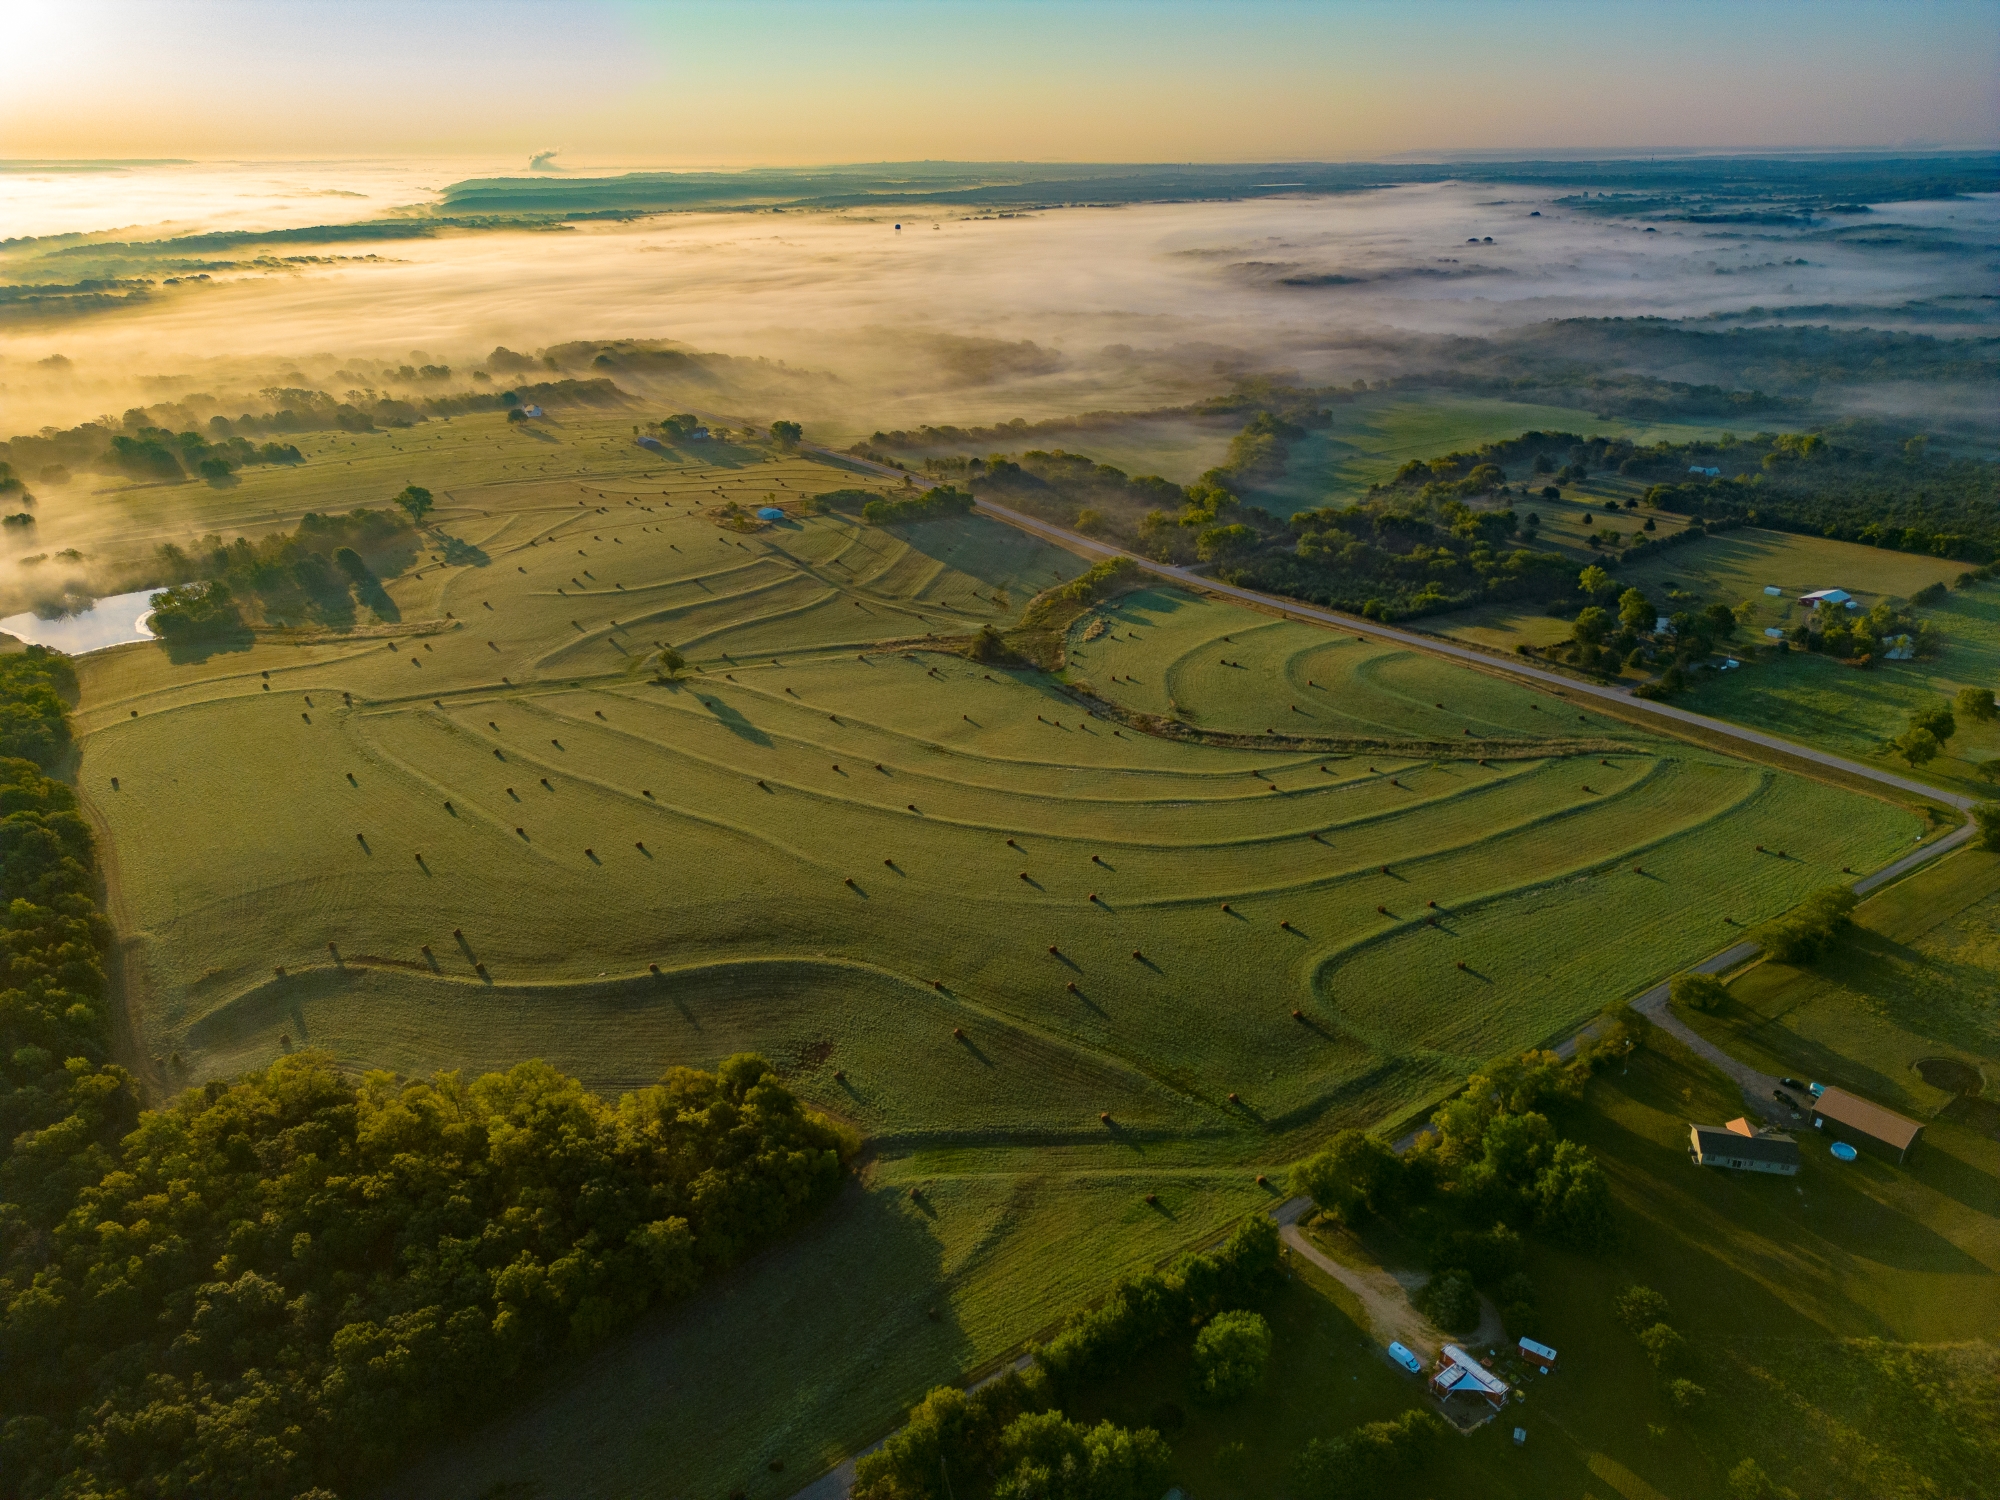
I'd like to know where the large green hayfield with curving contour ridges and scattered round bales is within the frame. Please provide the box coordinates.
[58,406,1922,1496]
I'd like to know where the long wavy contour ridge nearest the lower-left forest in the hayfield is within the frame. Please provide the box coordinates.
[178,954,1214,1140]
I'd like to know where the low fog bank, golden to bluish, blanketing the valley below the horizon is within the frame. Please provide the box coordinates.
[0,184,2000,436]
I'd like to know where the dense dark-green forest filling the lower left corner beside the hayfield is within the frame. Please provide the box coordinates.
[0,646,854,1500]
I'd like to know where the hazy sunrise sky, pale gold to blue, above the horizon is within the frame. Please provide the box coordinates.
[0,0,2000,166]
